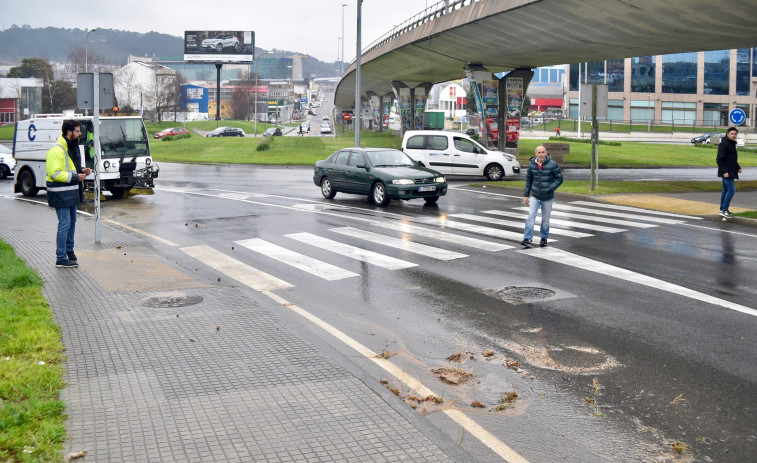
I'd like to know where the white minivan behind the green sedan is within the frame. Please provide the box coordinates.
[402,130,520,180]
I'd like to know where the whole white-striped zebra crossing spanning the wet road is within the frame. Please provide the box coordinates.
[182,201,699,291]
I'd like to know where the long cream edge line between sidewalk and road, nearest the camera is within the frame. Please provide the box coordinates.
[263,291,528,463]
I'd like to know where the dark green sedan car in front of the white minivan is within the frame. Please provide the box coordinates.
[313,148,447,206]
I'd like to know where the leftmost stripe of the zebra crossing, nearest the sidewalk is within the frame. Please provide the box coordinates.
[181,245,294,291]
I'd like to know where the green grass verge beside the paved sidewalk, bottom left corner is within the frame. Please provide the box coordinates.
[0,240,66,462]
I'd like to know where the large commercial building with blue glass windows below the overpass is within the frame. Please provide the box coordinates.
[564,48,757,127]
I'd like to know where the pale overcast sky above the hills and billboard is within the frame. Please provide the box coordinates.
[0,0,438,62]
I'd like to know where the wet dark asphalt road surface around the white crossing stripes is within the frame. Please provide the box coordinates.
[0,164,757,462]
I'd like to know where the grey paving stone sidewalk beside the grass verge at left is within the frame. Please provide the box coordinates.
[0,197,458,462]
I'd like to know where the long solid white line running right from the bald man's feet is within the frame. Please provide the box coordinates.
[516,248,757,317]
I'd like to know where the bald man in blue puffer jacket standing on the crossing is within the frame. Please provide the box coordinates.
[520,146,563,248]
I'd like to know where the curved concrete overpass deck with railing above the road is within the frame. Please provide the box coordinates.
[335,0,757,110]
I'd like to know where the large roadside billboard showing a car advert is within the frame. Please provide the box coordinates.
[184,31,255,63]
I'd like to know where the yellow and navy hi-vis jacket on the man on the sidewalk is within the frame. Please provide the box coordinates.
[45,135,79,207]
